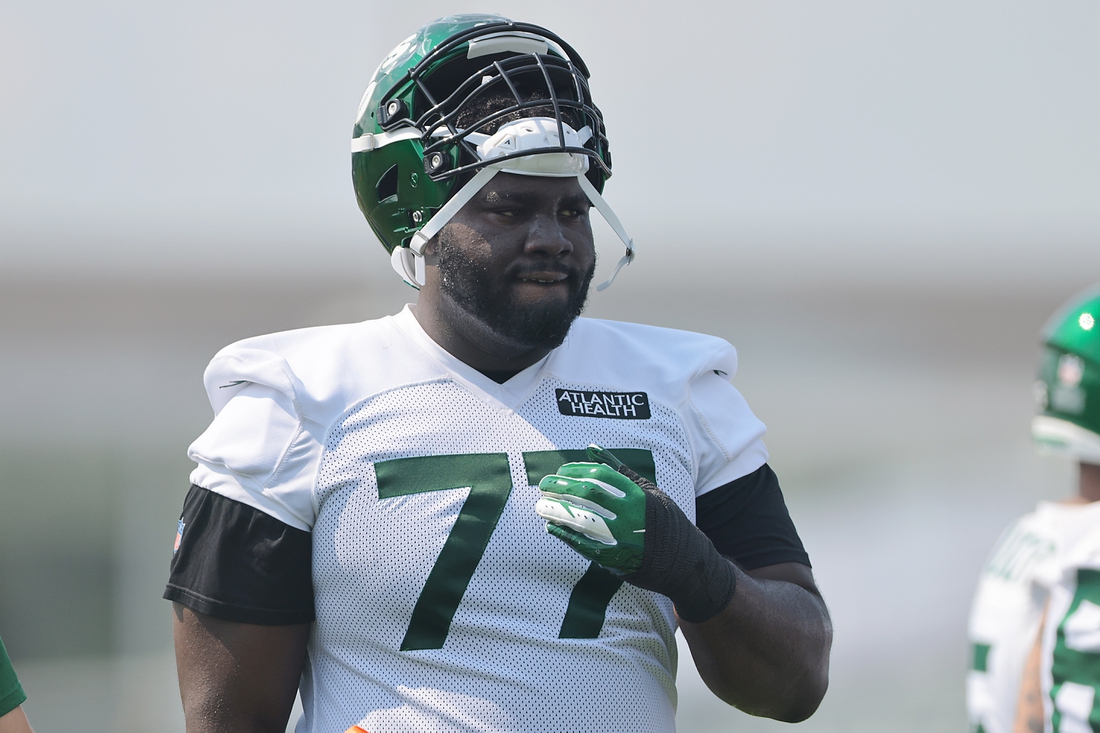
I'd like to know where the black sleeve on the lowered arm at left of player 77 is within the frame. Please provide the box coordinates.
[164,485,314,626]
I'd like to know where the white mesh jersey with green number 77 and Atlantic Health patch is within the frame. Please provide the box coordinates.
[189,308,767,733]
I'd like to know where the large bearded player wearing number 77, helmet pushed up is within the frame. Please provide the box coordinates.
[165,15,832,733]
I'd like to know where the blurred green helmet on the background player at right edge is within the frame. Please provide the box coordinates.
[1032,286,1100,463]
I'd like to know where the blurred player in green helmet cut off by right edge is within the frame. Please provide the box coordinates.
[967,288,1100,733]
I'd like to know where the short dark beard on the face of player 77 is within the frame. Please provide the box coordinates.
[438,237,596,350]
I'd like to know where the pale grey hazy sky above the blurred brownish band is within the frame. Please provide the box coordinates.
[0,0,1100,287]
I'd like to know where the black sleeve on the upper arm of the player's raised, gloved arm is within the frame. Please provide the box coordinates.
[695,463,810,570]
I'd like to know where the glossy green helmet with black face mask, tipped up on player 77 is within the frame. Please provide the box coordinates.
[351,14,634,289]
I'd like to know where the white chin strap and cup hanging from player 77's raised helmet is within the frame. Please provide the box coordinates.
[389,117,635,291]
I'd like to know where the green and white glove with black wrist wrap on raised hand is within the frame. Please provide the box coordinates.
[535,445,736,623]
